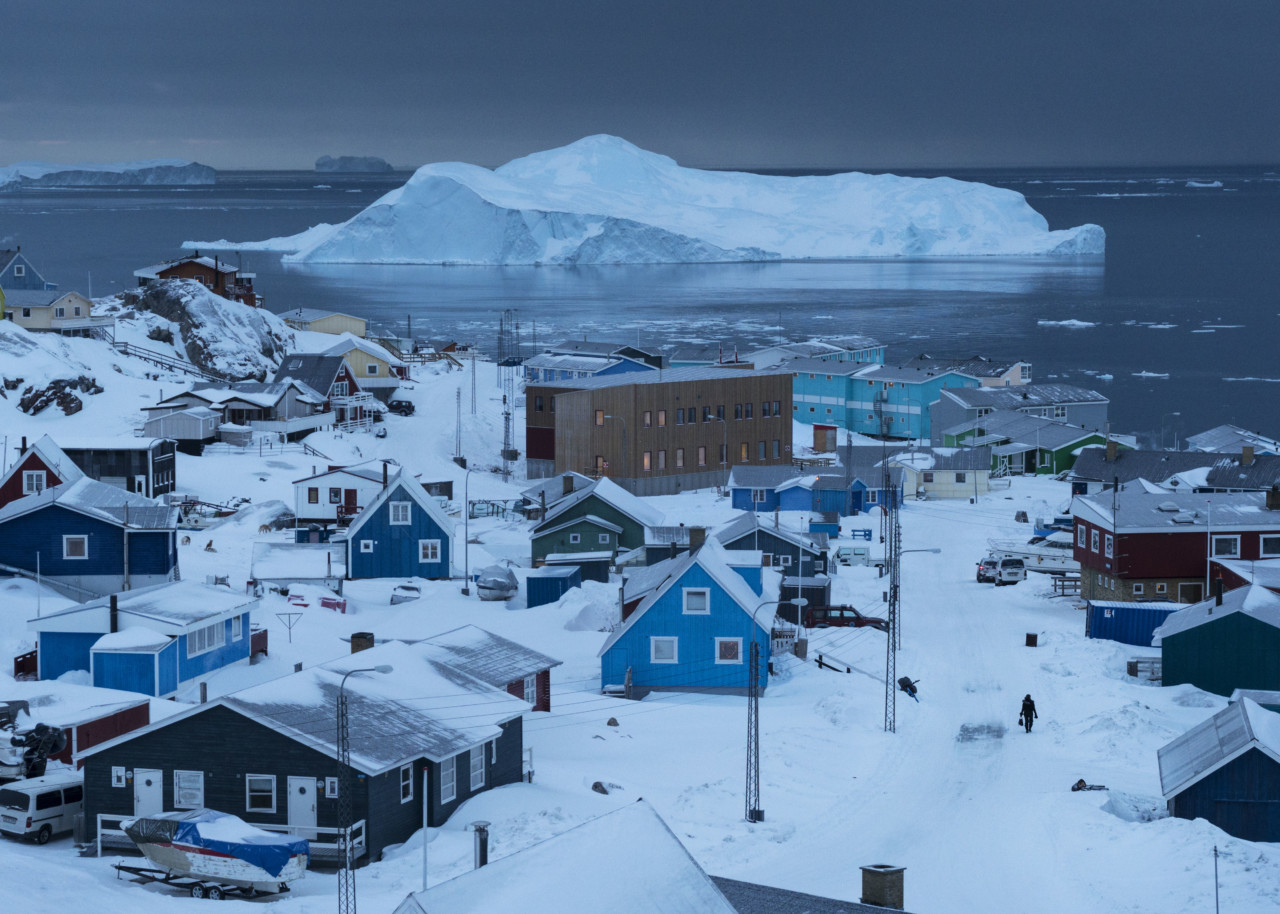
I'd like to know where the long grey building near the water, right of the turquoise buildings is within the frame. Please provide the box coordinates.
[929,384,1111,447]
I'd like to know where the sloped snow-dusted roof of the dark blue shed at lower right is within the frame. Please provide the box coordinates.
[1157,698,1280,800]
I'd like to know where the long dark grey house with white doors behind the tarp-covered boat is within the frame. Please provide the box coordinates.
[83,641,530,863]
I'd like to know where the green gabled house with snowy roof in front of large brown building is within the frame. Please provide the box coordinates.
[531,479,663,565]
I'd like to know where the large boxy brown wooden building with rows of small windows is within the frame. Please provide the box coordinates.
[525,367,791,495]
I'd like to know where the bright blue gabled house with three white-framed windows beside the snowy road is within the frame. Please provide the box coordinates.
[600,540,773,696]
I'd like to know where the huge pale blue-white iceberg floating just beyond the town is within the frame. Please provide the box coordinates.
[186,136,1106,265]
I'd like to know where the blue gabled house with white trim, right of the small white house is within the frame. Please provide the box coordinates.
[333,472,453,580]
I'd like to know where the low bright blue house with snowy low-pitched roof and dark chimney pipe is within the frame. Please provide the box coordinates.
[27,581,257,698]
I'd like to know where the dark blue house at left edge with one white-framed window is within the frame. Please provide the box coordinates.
[0,477,178,599]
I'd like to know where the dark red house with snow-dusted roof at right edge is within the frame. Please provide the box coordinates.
[1071,486,1280,603]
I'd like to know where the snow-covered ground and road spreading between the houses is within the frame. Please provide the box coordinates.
[0,330,1280,914]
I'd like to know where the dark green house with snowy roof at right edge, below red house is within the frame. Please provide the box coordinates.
[1153,584,1280,695]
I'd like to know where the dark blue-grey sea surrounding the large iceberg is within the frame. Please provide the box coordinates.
[0,166,1280,445]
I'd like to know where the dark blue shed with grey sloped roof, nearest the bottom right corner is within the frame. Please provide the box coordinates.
[1158,698,1280,841]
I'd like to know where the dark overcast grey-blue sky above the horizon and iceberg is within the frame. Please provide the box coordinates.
[0,0,1280,169]
